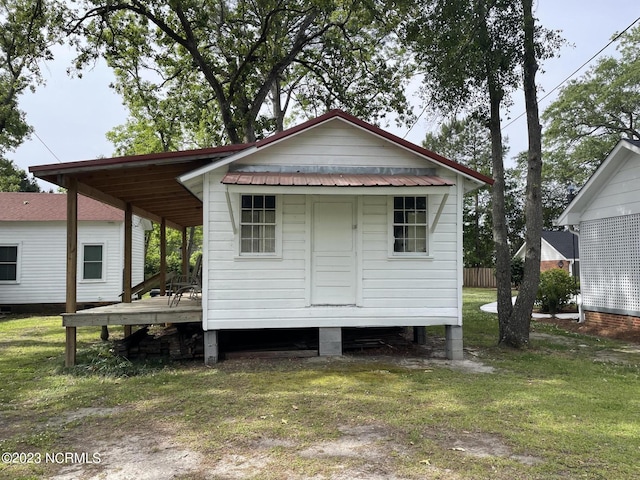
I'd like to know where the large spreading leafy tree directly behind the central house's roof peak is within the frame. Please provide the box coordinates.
[67,0,411,144]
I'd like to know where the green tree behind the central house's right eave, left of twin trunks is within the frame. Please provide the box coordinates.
[422,117,494,267]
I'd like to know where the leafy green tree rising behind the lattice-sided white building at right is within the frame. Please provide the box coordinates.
[543,26,640,188]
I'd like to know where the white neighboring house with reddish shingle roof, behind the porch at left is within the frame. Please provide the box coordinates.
[0,193,151,312]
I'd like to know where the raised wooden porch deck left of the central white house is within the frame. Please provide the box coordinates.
[62,296,202,327]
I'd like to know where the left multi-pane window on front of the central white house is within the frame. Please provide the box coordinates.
[240,195,276,255]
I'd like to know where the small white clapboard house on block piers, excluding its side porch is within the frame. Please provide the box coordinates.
[179,110,492,362]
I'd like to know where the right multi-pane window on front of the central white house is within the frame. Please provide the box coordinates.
[393,197,429,255]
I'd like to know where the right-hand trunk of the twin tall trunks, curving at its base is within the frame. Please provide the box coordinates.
[500,0,542,347]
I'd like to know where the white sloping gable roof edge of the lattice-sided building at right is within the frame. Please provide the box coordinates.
[556,139,640,225]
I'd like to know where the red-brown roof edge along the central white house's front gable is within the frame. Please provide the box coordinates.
[255,109,494,185]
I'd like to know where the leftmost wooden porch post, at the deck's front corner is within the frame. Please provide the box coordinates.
[64,178,78,367]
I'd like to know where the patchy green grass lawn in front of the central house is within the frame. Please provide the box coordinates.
[0,289,640,479]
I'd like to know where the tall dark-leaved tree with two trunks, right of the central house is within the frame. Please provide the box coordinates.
[404,0,557,347]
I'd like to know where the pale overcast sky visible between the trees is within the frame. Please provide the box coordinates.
[7,0,640,188]
